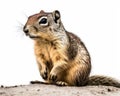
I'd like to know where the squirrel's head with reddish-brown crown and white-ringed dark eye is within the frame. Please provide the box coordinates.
[23,10,64,39]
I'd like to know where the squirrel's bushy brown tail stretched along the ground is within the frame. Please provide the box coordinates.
[88,75,120,88]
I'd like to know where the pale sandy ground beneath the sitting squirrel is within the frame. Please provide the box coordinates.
[0,84,120,96]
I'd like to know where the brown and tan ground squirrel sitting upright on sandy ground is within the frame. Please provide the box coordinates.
[23,10,120,87]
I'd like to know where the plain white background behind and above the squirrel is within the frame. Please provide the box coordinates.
[0,0,120,86]
